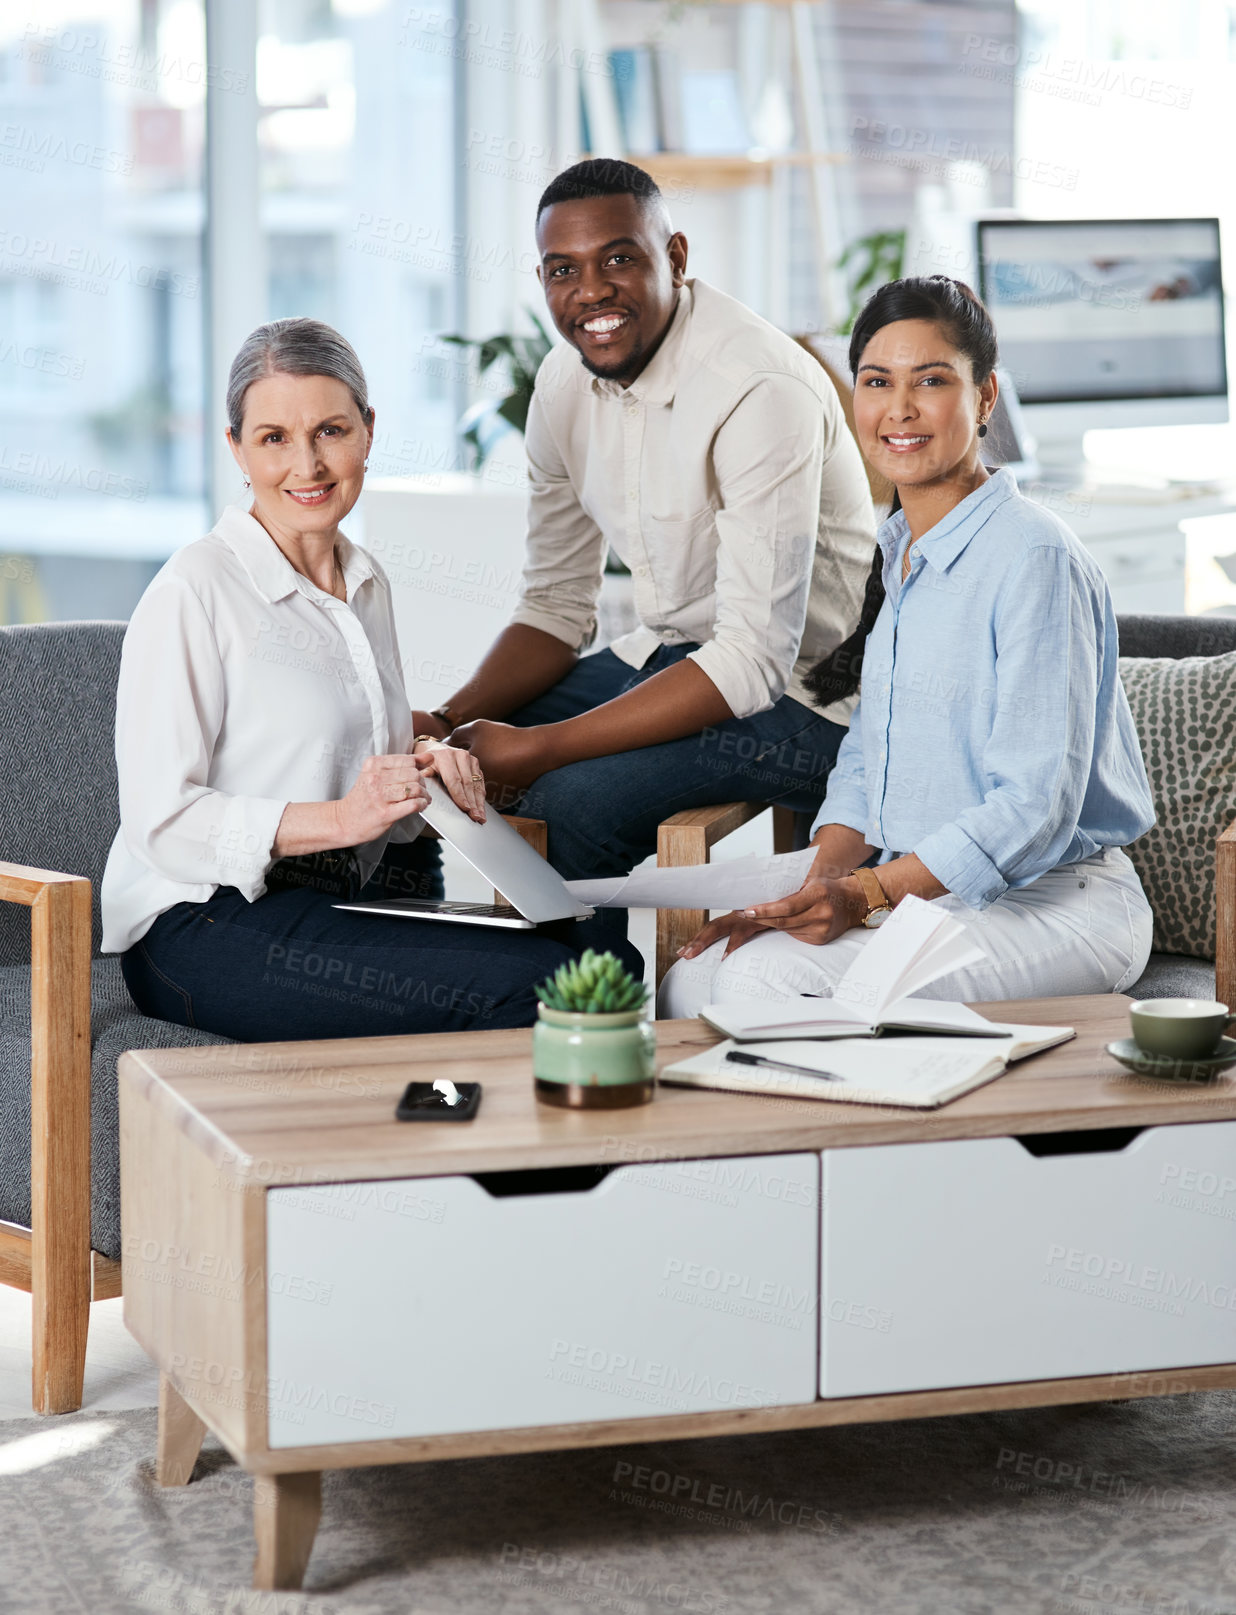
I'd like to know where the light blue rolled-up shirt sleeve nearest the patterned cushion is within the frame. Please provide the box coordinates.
[913,546,1102,909]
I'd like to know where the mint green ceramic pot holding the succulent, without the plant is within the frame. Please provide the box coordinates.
[532,1005,656,1110]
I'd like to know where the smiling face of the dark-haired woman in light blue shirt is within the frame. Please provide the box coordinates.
[855,320,995,488]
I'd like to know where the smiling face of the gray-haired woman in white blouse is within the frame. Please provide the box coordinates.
[228,375,373,538]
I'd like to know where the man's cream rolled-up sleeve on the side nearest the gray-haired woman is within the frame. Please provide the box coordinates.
[511,381,606,651]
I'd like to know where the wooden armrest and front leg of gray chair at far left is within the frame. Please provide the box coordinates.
[0,862,92,1413]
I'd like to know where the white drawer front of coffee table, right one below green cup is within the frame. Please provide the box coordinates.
[821,1122,1236,1397]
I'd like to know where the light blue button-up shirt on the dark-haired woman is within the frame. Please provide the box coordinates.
[814,470,1154,909]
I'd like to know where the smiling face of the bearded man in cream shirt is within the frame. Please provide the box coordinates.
[536,195,687,386]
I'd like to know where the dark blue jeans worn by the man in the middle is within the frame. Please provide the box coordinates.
[507,644,845,891]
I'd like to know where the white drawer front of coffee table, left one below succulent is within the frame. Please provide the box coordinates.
[267,1153,819,1447]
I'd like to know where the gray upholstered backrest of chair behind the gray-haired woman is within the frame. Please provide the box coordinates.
[0,622,125,966]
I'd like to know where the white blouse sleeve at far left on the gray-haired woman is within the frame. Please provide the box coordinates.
[116,577,288,903]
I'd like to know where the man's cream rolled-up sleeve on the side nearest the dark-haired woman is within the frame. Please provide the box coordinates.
[690,375,824,717]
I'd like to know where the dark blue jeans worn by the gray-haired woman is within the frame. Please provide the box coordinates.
[121,840,643,1043]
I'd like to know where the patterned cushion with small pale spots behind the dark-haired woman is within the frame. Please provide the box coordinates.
[1120,651,1236,959]
